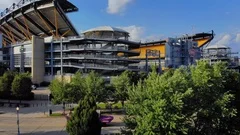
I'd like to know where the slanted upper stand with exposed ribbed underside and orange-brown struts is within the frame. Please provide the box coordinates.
[0,0,79,45]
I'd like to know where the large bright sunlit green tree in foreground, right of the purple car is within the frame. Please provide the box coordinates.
[124,68,192,135]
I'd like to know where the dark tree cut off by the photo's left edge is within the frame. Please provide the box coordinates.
[0,71,15,99]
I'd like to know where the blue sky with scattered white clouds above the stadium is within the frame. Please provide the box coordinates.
[0,0,240,52]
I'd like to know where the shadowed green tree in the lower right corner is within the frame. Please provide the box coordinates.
[184,61,240,135]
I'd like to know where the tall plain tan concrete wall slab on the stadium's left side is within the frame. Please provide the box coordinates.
[32,36,45,84]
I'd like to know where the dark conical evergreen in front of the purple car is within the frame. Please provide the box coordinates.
[67,95,101,135]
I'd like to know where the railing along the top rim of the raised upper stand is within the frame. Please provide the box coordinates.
[0,0,41,19]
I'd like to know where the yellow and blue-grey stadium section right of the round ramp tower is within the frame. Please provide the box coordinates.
[132,31,214,70]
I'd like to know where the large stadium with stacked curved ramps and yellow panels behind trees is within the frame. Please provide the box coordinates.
[0,0,214,83]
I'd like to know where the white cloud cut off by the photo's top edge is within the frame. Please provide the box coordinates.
[107,0,133,14]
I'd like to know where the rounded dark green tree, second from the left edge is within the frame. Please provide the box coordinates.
[12,73,32,102]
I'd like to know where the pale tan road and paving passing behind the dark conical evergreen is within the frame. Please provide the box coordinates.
[0,87,123,135]
